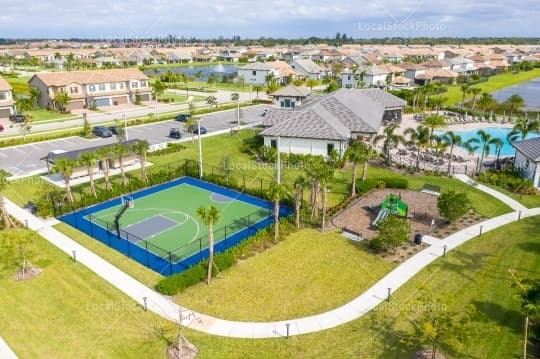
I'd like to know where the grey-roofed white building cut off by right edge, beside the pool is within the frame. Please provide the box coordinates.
[512,137,540,189]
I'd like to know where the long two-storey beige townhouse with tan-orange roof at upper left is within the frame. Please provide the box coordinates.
[28,69,152,111]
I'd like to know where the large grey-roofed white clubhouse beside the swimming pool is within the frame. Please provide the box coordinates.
[262,89,405,156]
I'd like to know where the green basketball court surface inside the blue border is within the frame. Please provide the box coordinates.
[87,183,272,262]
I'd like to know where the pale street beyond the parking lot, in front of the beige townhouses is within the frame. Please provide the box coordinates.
[0,90,267,138]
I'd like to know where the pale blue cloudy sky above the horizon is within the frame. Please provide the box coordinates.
[0,0,540,39]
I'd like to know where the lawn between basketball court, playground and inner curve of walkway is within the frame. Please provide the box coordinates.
[176,229,394,321]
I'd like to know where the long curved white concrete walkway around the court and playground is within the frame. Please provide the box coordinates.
[6,183,540,338]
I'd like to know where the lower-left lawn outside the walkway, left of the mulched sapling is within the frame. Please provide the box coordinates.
[0,231,173,359]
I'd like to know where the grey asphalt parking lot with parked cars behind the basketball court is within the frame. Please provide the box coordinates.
[0,105,265,177]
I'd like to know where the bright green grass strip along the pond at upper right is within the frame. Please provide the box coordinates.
[443,68,540,106]
